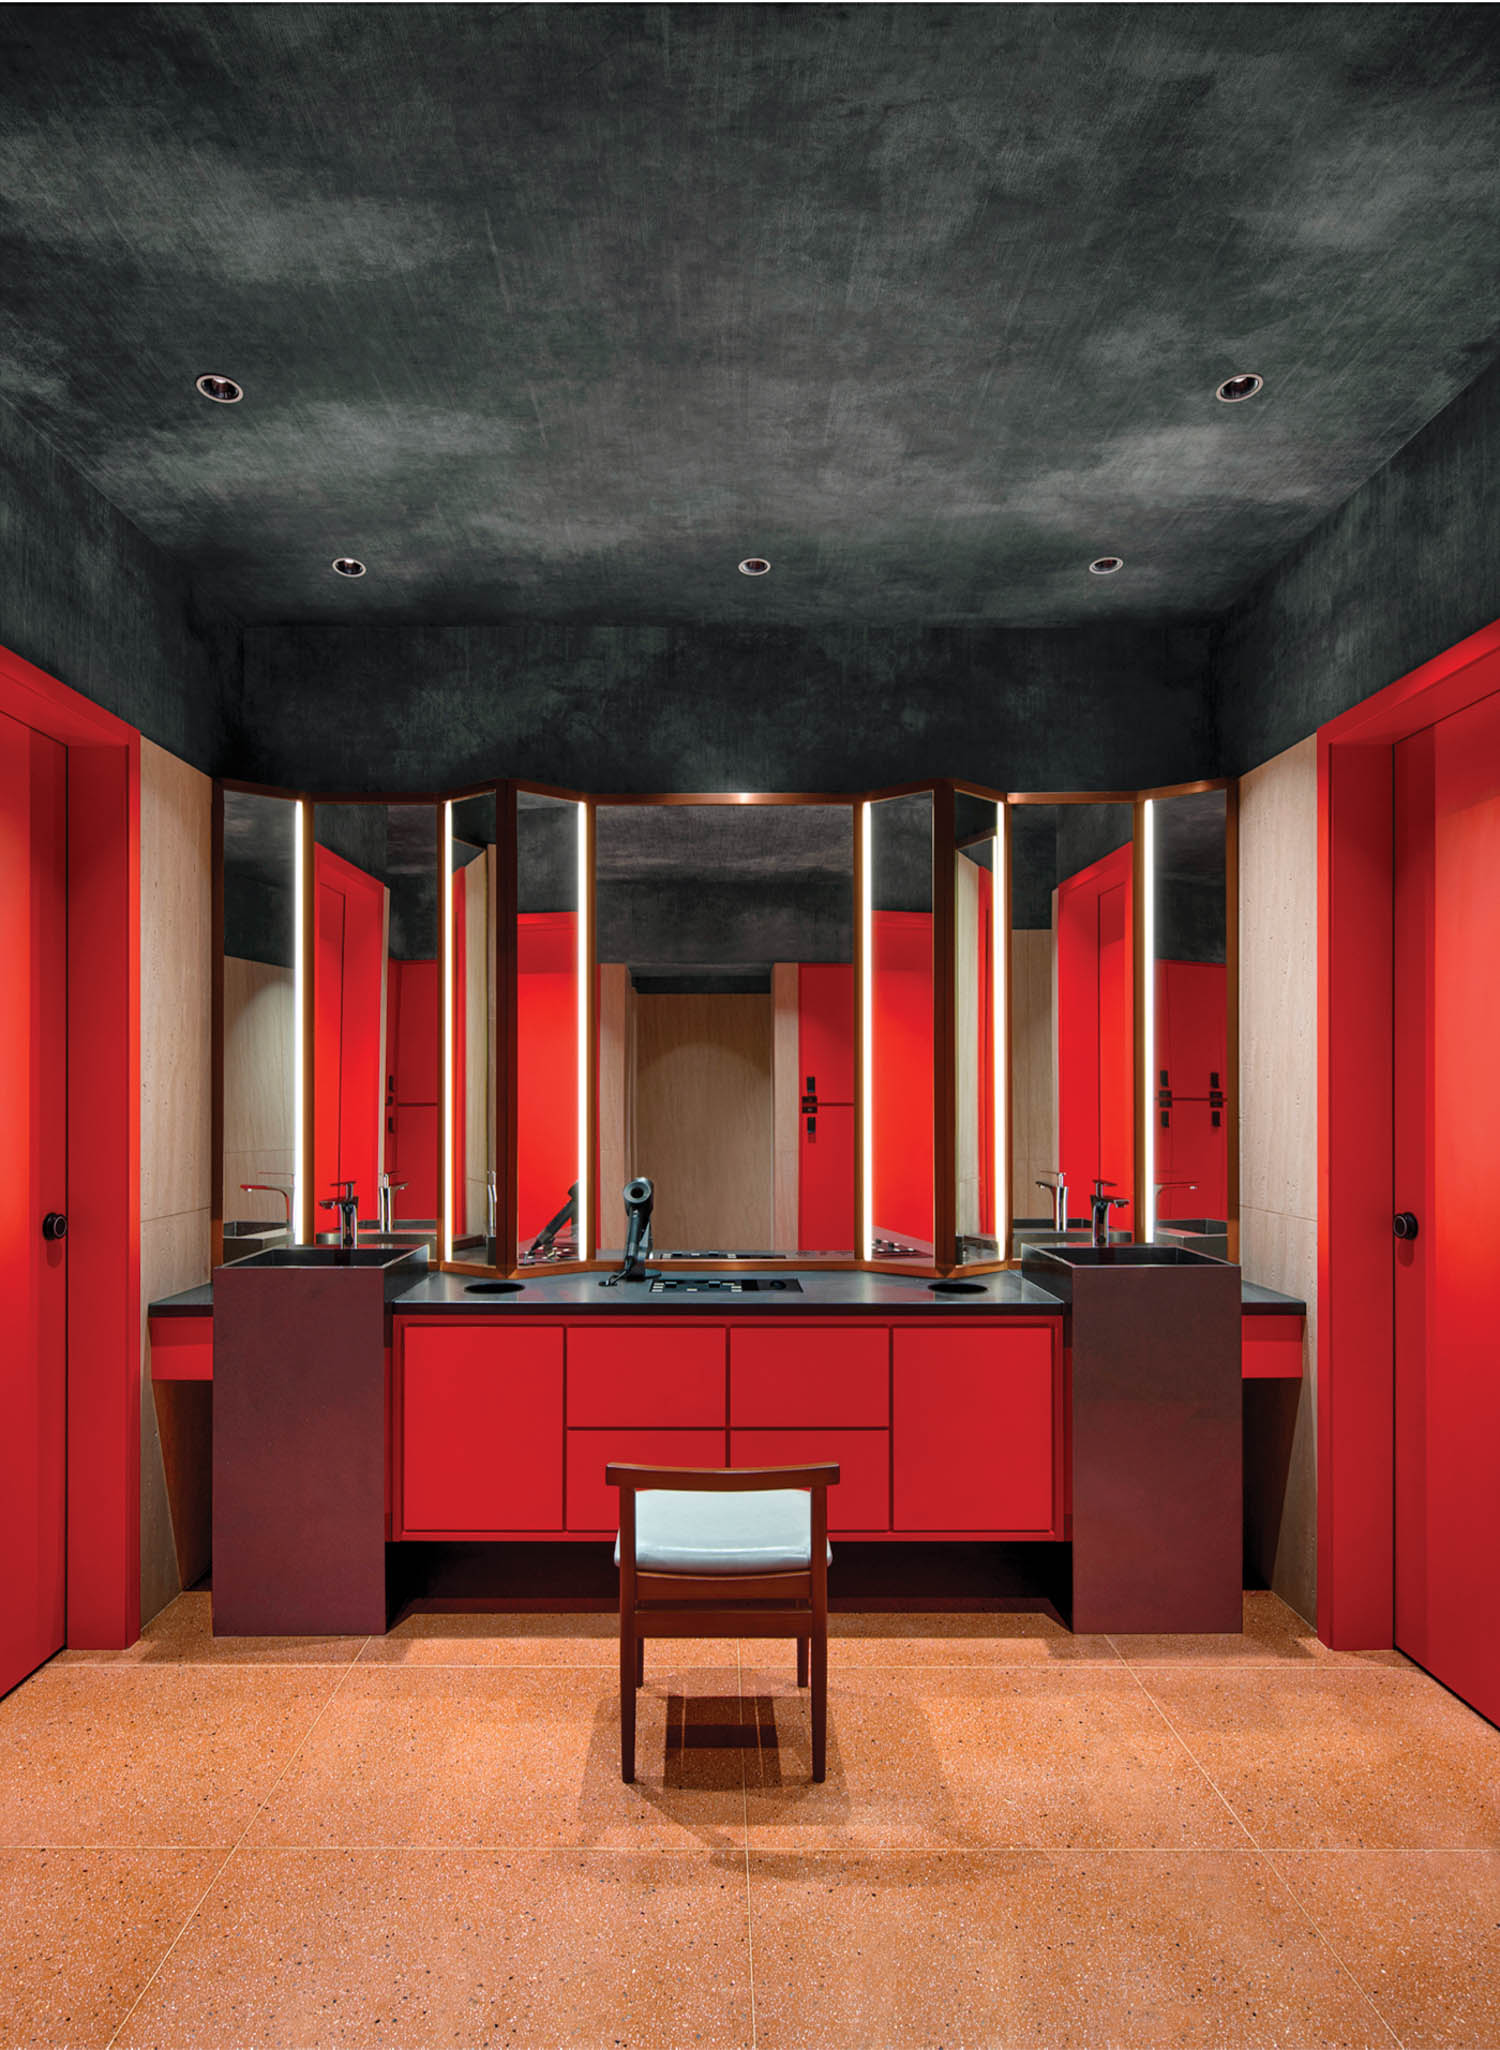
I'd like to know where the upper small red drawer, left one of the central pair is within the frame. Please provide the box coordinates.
[568,1324,723,1429]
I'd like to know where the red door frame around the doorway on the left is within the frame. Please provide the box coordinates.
[0,648,141,1650]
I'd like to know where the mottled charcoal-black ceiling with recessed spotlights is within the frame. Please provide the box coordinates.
[0,4,1500,625]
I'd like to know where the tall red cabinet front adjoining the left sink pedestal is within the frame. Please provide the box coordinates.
[398,1322,564,1531]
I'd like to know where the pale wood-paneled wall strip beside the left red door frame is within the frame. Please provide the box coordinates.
[141,740,213,1624]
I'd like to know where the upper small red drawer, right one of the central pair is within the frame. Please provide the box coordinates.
[730,1324,891,1426]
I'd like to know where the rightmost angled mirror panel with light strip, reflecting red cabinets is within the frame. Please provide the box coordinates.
[1141,789,1234,1259]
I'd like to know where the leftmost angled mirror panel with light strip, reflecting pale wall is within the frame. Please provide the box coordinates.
[219,789,303,1259]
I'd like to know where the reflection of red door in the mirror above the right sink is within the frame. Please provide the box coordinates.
[1057,847,1135,1230]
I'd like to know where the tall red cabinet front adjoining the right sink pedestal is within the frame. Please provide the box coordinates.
[891,1324,1057,1531]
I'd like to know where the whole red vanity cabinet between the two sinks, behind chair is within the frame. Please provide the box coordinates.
[391,1314,1064,1540]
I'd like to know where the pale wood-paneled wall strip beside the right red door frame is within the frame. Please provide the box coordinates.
[1240,736,1318,1620]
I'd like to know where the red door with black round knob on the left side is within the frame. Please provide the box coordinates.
[0,715,68,1693]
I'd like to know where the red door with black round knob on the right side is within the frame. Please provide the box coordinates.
[1393,697,1500,1722]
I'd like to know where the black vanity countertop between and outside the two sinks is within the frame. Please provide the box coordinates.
[150,1267,1307,1318]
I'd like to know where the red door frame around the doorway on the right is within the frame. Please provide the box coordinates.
[1318,621,1500,1650]
